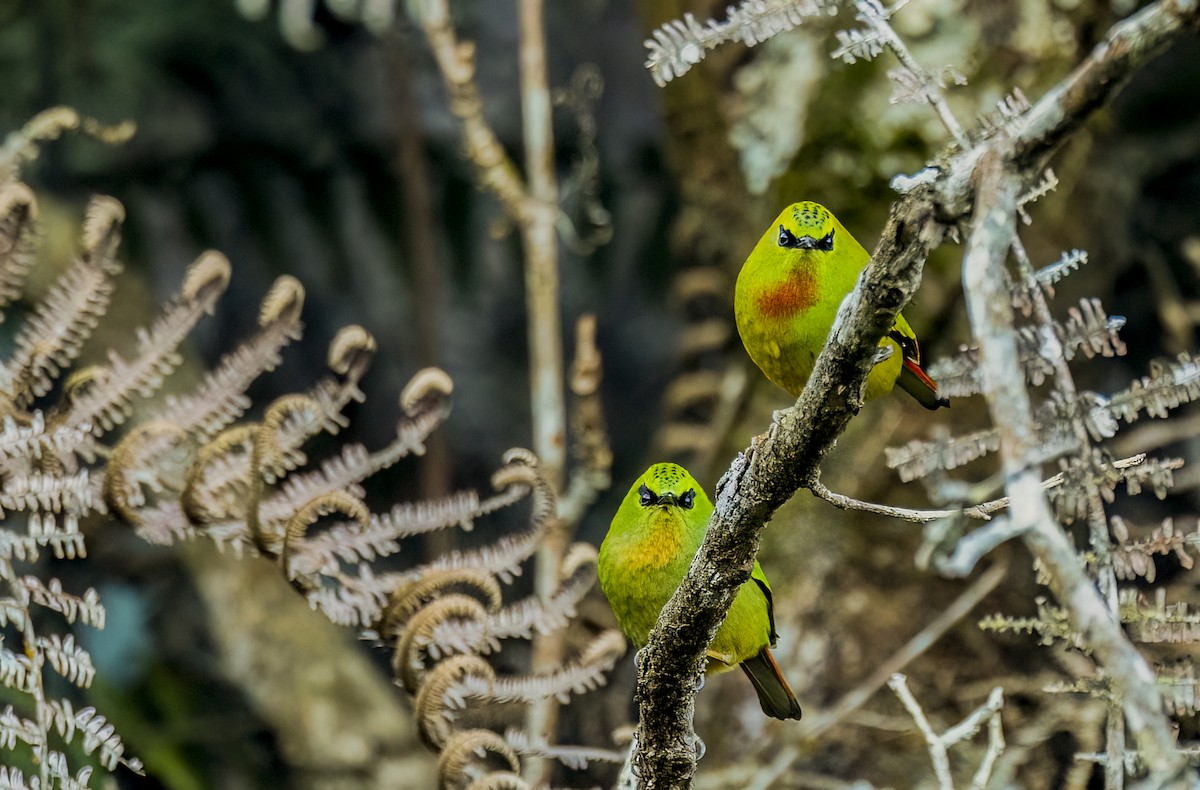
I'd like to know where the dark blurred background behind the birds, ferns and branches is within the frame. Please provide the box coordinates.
[0,0,1200,788]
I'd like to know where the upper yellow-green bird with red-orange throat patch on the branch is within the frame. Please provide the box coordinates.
[733,202,950,409]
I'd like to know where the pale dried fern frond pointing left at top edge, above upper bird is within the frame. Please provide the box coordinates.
[646,0,836,88]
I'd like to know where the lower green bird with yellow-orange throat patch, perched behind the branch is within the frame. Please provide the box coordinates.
[600,463,800,719]
